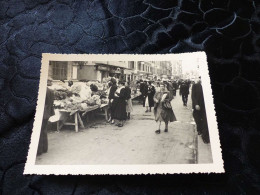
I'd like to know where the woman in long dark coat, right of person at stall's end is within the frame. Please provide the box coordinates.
[114,81,127,127]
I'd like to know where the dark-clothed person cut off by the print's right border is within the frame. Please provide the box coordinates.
[191,79,210,143]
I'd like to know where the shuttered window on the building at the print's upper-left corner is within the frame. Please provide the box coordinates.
[52,62,68,80]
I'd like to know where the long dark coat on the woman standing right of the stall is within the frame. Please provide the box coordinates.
[113,87,127,121]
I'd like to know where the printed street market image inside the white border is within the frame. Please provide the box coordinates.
[35,59,213,165]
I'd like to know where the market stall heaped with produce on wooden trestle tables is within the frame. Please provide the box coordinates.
[50,81,108,132]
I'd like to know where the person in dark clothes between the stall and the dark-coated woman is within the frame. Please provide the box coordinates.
[108,78,117,124]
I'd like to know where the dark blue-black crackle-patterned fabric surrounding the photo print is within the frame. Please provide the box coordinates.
[0,0,260,194]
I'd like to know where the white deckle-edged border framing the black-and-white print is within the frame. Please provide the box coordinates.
[24,52,225,175]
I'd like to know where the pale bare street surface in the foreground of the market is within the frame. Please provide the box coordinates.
[36,90,212,165]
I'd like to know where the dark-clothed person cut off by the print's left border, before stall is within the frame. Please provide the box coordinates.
[37,79,55,155]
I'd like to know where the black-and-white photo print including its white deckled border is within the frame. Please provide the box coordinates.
[25,52,224,174]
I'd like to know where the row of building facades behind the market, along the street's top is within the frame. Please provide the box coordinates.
[49,61,175,82]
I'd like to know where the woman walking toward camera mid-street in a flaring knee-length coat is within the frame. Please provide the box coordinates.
[154,84,177,134]
